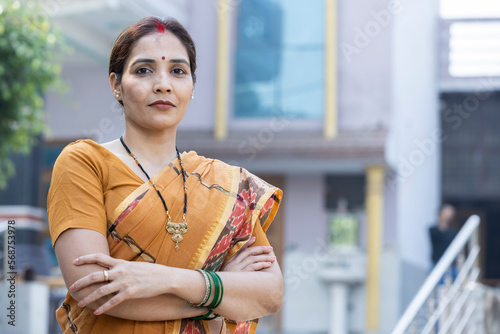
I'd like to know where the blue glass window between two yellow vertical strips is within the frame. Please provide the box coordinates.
[234,0,324,119]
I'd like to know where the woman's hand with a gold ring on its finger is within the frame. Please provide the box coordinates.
[69,253,169,315]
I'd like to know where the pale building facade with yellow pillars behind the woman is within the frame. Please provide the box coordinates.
[0,0,460,333]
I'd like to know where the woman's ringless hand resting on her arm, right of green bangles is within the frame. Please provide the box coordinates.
[221,237,276,272]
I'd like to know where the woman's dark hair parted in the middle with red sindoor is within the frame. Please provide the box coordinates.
[109,16,196,83]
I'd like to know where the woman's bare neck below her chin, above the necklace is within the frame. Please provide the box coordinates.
[123,127,177,166]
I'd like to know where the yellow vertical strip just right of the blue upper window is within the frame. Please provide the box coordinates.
[324,0,338,139]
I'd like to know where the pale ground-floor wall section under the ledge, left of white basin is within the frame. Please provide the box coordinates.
[282,174,328,333]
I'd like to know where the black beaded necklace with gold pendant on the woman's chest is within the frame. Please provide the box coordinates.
[120,136,188,250]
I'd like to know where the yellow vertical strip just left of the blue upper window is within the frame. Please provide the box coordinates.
[214,0,233,139]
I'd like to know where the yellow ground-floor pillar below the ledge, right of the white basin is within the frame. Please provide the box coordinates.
[366,166,385,331]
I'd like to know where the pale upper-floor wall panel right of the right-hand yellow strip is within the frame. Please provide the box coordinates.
[337,0,393,131]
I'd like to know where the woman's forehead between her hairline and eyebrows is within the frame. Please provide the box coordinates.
[127,31,189,63]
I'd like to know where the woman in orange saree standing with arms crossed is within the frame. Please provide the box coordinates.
[47,17,283,334]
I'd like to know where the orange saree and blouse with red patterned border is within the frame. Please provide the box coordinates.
[47,140,282,334]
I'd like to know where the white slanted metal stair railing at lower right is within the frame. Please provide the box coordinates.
[392,215,483,334]
